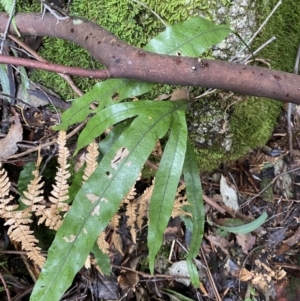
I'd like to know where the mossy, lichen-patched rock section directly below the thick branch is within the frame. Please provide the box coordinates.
[188,95,281,171]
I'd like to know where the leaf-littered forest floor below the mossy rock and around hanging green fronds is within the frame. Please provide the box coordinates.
[0,99,300,301]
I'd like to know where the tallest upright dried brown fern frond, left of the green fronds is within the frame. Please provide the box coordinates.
[37,131,70,230]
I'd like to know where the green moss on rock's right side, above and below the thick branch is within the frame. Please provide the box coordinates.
[192,0,300,170]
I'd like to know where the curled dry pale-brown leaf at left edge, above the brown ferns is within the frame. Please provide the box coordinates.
[0,114,23,160]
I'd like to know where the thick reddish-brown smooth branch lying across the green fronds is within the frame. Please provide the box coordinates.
[0,13,300,104]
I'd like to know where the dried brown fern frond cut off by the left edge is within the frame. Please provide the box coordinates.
[0,162,19,218]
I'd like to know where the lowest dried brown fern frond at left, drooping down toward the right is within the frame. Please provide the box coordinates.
[4,207,45,268]
